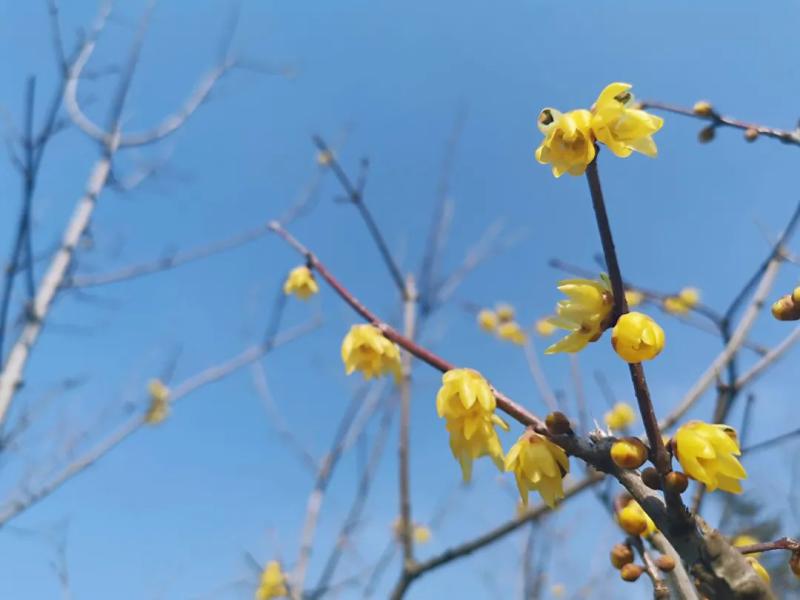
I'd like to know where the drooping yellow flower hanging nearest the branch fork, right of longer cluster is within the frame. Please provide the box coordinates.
[505,431,569,508]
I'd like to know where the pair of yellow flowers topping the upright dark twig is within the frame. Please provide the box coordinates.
[536,83,664,177]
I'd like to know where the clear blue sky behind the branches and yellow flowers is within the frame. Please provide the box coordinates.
[0,0,800,599]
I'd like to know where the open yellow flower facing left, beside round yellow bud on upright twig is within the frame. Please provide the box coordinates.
[544,275,614,354]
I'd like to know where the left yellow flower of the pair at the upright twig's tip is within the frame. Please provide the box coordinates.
[536,108,595,177]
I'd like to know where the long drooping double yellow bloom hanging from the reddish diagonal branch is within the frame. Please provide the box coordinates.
[436,369,508,481]
